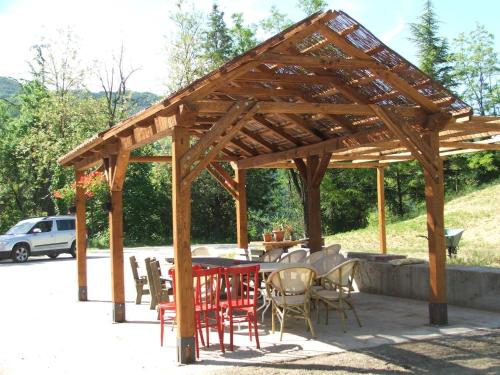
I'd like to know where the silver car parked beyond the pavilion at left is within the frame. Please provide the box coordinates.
[0,216,76,262]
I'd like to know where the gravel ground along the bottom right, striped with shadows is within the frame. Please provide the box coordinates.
[206,329,500,375]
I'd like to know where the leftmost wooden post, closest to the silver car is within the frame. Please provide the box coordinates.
[75,170,88,301]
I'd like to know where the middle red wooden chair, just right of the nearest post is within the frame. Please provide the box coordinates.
[193,267,224,357]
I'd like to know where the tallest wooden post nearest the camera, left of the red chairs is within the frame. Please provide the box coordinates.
[172,126,195,364]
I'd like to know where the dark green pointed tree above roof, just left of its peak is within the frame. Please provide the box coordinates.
[203,3,233,71]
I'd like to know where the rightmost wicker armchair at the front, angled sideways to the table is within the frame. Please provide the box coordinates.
[312,259,361,332]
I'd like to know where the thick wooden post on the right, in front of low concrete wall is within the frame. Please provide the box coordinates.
[424,131,448,325]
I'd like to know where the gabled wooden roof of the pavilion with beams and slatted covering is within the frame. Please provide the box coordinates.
[59,11,500,170]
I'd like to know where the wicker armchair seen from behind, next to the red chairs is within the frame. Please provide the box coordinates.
[266,267,316,341]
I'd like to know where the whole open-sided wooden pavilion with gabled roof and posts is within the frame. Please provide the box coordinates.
[59,11,500,363]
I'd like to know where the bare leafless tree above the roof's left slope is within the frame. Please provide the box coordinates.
[97,44,138,127]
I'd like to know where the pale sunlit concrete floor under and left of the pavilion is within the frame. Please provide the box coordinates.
[0,248,500,374]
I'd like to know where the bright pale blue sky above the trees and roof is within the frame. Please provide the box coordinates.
[0,0,500,94]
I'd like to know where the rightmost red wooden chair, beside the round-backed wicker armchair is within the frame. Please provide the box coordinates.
[221,265,260,350]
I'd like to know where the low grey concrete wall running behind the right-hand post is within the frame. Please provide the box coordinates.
[356,260,500,312]
